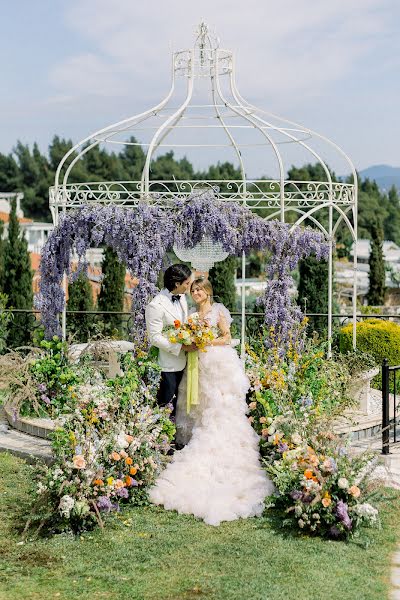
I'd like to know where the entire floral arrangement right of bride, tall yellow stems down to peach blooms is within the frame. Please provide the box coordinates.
[246,321,379,538]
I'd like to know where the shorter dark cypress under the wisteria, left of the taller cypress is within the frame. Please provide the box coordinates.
[67,273,94,342]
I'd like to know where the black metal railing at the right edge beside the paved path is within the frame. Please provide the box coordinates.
[382,358,400,454]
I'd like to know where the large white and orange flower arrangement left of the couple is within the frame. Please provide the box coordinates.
[24,353,175,532]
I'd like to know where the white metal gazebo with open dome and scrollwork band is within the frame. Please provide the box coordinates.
[50,23,357,352]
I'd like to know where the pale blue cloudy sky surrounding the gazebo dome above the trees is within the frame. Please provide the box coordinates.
[0,0,400,175]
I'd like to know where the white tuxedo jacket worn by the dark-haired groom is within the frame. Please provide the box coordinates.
[146,292,188,372]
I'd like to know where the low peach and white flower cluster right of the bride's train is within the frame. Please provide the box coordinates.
[264,403,379,538]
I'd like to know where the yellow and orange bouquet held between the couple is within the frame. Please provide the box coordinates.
[164,313,217,352]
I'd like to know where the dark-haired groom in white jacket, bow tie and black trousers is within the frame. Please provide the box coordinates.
[146,265,192,417]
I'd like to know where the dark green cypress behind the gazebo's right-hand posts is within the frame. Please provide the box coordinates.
[297,256,329,337]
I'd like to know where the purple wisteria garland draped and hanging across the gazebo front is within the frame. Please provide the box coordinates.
[37,190,329,346]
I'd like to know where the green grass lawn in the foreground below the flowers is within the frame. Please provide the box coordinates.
[0,454,400,600]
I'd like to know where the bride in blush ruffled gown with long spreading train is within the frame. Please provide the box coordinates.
[150,278,273,525]
